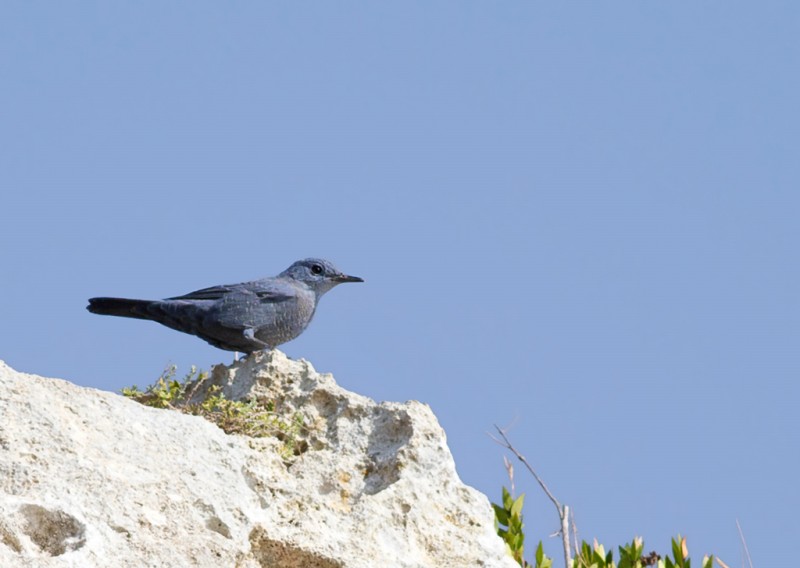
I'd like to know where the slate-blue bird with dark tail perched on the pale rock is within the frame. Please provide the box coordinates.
[86,258,364,354]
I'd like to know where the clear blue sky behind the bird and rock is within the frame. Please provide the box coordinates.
[0,0,800,566]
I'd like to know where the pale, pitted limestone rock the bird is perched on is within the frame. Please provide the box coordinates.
[0,351,517,568]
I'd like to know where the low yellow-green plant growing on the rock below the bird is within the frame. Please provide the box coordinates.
[122,365,307,459]
